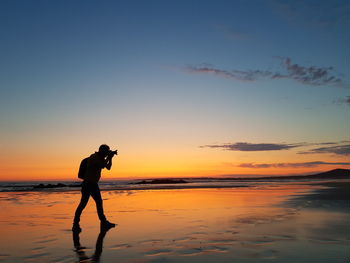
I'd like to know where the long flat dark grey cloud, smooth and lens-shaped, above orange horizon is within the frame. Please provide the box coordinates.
[200,142,304,152]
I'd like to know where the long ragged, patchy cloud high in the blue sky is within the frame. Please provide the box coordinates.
[185,57,348,87]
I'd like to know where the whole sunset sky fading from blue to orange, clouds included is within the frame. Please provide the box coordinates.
[0,0,350,180]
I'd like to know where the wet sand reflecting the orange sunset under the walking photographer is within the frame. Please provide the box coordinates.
[0,181,350,263]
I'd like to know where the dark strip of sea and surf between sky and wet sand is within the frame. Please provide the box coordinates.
[0,174,350,192]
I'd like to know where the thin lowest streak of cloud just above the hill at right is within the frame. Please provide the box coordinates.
[237,161,350,169]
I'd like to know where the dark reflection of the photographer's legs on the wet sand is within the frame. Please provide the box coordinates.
[73,227,111,262]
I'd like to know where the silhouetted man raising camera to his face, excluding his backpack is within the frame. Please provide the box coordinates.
[72,144,117,232]
